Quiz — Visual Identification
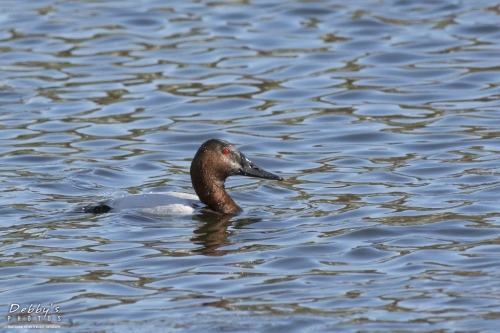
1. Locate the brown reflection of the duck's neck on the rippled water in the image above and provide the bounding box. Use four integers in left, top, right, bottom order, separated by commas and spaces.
191, 209, 260, 256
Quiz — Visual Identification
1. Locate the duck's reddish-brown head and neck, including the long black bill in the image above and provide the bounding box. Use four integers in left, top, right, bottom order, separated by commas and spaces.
190, 139, 283, 214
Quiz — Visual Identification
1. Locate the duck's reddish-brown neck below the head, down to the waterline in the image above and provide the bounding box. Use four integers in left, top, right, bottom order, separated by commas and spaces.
192, 177, 243, 214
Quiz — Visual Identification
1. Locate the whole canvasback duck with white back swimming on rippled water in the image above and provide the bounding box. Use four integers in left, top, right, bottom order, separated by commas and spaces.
82, 139, 283, 215
